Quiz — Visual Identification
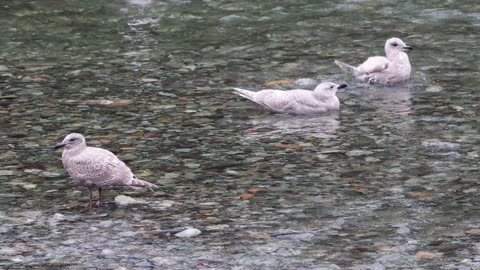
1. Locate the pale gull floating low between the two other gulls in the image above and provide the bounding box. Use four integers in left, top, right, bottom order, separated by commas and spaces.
233, 82, 347, 114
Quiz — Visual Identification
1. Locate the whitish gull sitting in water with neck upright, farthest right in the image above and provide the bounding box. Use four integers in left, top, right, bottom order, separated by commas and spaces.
335, 37, 412, 85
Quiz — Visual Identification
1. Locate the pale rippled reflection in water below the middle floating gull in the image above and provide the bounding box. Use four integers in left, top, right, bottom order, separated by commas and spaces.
242, 112, 340, 140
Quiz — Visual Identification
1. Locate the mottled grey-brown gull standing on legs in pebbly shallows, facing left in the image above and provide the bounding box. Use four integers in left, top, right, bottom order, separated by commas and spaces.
54, 133, 157, 209
